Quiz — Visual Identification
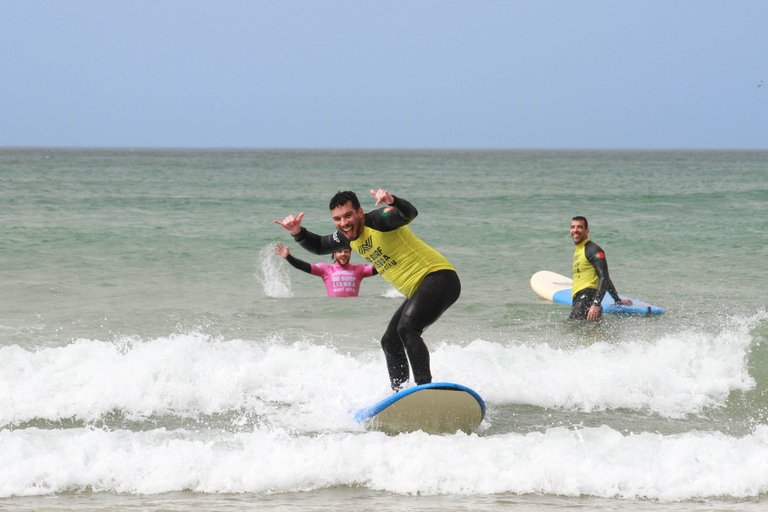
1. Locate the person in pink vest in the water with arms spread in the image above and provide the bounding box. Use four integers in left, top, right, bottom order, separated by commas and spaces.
275, 244, 378, 297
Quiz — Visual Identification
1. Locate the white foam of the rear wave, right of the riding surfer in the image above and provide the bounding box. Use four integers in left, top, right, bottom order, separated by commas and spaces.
433, 318, 755, 418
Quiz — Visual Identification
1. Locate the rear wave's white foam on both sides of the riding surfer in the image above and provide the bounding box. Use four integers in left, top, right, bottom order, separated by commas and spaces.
0, 314, 755, 431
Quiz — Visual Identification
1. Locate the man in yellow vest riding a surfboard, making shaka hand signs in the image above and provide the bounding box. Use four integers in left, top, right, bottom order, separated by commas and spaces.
275, 189, 461, 391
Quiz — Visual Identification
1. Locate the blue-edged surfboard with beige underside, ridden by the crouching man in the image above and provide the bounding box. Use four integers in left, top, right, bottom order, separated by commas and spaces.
355, 382, 485, 434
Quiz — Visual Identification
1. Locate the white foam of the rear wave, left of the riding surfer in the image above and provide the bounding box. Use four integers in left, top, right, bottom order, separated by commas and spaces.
0, 333, 386, 430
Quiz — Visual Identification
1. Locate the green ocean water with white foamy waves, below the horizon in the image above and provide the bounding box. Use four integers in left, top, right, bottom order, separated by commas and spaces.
0, 149, 768, 511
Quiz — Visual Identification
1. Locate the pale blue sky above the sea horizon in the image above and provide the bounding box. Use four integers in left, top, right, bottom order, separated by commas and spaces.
0, 0, 768, 149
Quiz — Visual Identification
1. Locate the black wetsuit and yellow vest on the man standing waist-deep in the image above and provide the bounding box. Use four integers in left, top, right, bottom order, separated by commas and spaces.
570, 239, 620, 320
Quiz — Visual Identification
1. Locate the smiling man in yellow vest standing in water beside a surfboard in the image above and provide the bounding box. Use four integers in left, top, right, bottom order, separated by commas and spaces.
570, 217, 632, 322
